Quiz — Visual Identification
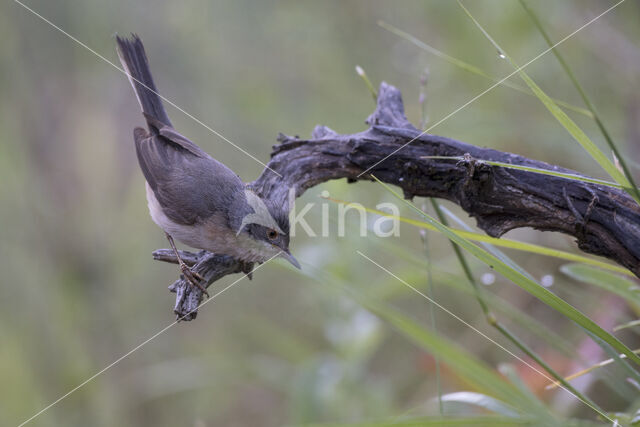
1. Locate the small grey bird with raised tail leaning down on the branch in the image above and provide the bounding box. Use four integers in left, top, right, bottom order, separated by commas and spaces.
116, 34, 300, 294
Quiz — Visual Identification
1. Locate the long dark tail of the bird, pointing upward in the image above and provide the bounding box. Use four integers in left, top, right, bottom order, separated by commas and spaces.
116, 34, 173, 130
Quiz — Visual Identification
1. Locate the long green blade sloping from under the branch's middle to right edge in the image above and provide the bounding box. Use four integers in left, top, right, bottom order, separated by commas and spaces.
372, 175, 640, 365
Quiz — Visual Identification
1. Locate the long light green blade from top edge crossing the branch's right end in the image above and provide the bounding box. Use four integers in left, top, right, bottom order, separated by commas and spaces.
458, 0, 640, 204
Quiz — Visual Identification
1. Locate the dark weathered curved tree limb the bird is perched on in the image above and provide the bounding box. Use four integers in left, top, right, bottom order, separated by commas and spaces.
154, 82, 640, 320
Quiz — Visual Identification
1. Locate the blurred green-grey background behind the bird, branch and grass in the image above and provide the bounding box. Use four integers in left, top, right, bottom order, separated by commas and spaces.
0, 0, 640, 427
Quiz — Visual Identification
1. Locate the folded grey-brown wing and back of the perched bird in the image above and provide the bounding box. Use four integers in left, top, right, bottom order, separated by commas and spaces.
134, 126, 244, 224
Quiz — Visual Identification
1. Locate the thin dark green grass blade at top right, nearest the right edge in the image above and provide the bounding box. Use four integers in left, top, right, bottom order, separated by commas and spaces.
520, 0, 640, 207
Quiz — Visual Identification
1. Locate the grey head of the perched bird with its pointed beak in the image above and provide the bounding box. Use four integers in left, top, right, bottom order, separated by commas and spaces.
231, 189, 300, 268
